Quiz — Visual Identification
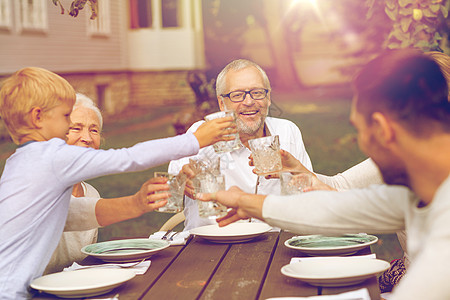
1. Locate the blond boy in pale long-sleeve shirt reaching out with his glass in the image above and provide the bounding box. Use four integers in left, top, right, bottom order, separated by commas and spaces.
0, 68, 235, 299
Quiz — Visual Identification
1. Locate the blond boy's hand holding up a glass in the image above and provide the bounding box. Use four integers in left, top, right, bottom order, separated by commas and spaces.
194, 117, 237, 148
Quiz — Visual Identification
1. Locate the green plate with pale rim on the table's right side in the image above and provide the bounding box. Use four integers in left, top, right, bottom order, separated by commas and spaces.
284, 233, 378, 255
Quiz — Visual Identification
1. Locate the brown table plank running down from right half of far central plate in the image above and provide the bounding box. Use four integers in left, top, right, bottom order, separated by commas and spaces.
200, 232, 278, 300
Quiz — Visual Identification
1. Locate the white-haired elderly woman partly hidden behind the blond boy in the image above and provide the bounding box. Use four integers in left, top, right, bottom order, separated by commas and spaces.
45, 94, 169, 274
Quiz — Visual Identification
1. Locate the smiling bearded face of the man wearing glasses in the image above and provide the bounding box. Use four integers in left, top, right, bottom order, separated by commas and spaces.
218, 66, 270, 138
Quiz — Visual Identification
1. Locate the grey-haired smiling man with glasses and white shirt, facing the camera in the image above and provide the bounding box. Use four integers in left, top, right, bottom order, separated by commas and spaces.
169, 59, 312, 230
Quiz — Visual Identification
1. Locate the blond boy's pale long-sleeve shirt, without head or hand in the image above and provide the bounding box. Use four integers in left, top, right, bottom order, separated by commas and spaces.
0, 134, 199, 299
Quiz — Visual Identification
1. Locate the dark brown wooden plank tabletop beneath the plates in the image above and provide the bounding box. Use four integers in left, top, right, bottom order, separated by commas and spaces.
33, 231, 380, 300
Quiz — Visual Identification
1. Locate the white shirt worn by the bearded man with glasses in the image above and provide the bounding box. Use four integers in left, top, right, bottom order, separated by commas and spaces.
169, 117, 312, 230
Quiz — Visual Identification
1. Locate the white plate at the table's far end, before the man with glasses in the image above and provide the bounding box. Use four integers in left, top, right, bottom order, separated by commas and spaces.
190, 223, 272, 243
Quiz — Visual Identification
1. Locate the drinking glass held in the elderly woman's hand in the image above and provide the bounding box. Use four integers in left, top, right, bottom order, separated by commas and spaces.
154, 172, 187, 213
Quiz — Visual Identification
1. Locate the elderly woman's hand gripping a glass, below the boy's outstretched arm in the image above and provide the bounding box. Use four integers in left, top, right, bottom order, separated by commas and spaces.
133, 177, 170, 213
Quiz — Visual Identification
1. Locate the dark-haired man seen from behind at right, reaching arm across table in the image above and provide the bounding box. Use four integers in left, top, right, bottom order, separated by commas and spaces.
198, 49, 450, 299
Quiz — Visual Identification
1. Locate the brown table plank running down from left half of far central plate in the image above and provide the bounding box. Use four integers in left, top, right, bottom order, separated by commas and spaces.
142, 237, 230, 300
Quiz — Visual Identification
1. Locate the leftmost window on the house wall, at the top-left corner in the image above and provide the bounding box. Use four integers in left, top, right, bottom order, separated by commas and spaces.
19, 0, 48, 30
